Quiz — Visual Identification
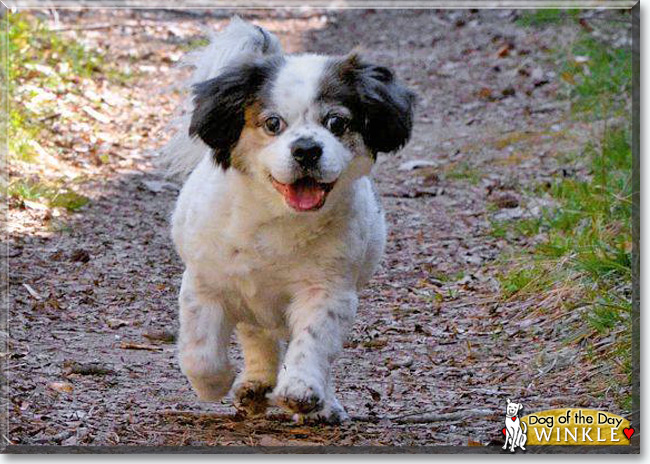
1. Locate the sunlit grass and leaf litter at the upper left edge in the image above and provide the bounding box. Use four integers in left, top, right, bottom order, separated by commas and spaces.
3, 12, 121, 211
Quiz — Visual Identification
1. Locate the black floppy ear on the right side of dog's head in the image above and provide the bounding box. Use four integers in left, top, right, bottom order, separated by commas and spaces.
347, 54, 415, 154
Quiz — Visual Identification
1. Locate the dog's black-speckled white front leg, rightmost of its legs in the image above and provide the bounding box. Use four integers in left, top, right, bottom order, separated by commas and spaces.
273, 289, 357, 422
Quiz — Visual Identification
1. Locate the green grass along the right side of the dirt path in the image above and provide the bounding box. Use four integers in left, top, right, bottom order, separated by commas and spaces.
491, 24, 632, 392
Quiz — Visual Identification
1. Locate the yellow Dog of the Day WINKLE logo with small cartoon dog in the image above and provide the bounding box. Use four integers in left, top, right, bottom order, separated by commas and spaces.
501, 399, 635, 453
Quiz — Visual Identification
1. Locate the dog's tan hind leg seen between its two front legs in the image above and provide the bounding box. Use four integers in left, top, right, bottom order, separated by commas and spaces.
234, 324, 280, 415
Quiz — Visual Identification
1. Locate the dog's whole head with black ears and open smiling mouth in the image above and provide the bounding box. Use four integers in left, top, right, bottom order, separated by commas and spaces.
190, 54, 414, 212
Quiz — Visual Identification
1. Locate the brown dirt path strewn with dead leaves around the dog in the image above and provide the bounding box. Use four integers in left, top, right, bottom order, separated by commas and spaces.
8, 10, 615, 446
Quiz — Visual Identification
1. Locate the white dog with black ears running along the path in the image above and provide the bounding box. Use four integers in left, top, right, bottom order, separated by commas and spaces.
165, 18, 414, 421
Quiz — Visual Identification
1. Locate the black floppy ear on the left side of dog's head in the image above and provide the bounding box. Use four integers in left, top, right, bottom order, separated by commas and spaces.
189, 56, 284, 169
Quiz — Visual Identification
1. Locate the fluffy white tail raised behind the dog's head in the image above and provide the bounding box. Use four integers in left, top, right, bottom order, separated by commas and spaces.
160, 16, 282, 178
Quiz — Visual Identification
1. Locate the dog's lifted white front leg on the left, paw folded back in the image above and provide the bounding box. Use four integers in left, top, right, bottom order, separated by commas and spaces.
178, 271, 234, 401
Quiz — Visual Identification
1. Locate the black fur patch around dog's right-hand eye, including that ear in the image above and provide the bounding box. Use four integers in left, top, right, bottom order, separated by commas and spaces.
319, 54, 415, 156
